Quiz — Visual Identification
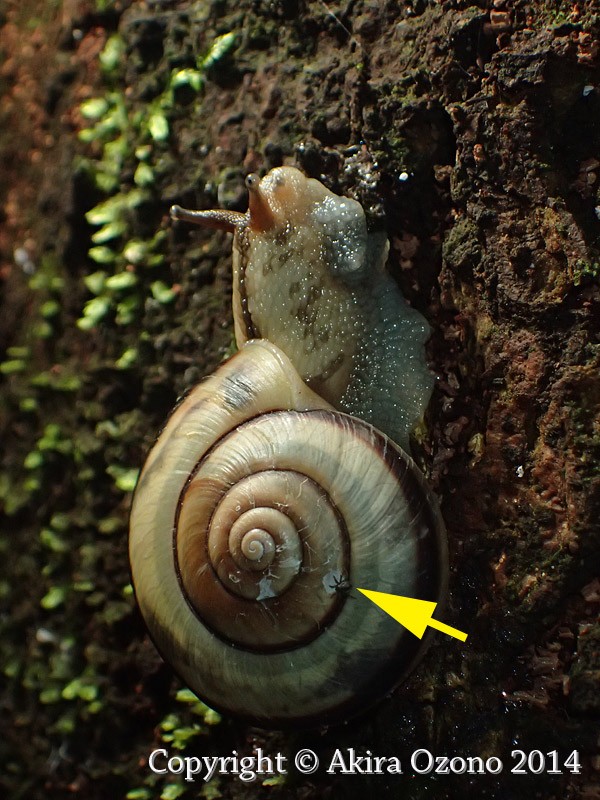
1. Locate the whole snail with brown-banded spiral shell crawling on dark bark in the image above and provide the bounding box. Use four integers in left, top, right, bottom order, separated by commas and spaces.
130, 167, 447, 728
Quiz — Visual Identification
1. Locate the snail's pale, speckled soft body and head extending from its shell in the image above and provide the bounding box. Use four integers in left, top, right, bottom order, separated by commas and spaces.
171, 167, 433, 449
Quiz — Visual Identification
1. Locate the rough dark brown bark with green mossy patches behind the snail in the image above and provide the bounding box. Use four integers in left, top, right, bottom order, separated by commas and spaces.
0, 0, 600, 800
